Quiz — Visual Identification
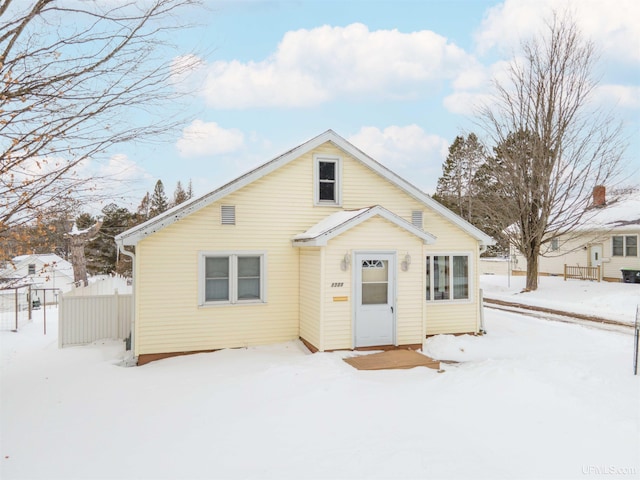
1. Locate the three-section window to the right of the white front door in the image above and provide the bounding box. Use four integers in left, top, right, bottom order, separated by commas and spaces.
426, 254, 471, 300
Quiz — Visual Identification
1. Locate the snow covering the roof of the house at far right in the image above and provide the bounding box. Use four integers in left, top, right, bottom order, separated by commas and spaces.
578, 190, 640, 231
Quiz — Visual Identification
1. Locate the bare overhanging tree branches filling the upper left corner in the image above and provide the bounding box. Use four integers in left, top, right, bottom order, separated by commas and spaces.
0, 0, 199, 235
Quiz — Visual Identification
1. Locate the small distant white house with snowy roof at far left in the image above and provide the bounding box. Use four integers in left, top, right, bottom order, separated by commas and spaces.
0, 253, 73, 292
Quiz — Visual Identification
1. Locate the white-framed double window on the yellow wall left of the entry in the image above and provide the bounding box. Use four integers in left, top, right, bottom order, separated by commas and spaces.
200, 252, 265, 305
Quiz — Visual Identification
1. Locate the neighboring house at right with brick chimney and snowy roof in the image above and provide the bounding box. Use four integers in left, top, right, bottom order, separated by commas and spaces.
515, 186, 640, 282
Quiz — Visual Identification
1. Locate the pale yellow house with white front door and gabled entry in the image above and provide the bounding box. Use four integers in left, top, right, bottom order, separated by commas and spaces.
116, 130, 493, 364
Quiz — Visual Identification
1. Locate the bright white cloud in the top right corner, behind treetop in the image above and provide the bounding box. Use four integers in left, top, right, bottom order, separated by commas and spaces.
476, 0, 640, 62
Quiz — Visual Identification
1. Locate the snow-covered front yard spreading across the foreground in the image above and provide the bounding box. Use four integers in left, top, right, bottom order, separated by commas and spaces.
0, 286, 640, 479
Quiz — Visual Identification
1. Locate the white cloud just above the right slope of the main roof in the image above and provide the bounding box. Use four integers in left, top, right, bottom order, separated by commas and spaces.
348, 125, 449, 192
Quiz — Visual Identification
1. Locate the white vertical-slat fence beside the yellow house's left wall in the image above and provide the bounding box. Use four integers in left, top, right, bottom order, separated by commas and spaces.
58, 292, 133, 348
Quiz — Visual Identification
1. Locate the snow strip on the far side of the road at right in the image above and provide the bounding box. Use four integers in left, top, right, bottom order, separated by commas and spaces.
480, 275, 640, 324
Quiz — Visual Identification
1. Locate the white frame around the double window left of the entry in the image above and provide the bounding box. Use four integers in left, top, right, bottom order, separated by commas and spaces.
198, 250, 267, 307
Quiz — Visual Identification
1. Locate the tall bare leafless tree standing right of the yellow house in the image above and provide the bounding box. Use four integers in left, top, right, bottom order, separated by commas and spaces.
479, 13, 625, 290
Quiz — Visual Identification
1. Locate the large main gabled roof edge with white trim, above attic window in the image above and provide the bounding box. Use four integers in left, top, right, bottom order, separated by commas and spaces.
115, 130, 495, 245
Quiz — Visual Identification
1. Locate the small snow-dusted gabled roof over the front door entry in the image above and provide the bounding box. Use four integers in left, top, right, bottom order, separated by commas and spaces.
293, 205, 436, 247
